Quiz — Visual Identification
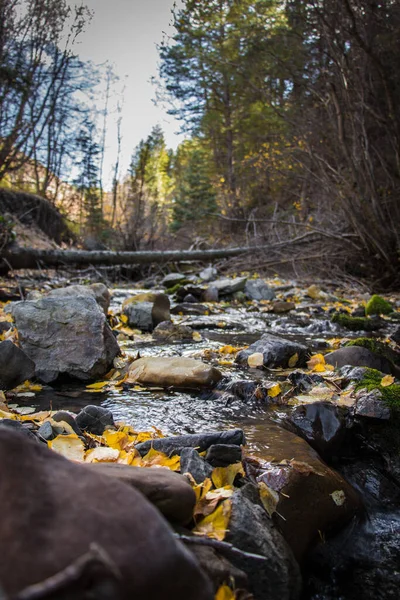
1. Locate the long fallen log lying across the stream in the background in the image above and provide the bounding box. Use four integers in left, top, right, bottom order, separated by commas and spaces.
0, 246, 264, 269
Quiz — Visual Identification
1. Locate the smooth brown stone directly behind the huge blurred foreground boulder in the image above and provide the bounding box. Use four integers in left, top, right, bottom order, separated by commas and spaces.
84, 462, 196, 525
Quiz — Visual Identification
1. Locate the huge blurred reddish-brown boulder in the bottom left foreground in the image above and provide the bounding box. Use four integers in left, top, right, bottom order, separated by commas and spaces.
0, 428, 213, 600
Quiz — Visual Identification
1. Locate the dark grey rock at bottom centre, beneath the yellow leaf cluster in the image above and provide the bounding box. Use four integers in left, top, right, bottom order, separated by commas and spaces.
225, 485, 301, 600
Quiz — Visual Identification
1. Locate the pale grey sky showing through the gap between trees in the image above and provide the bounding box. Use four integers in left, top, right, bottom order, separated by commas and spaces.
69, 0, 183, 188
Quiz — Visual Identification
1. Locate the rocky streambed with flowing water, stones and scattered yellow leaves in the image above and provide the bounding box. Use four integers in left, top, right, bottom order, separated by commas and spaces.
0, 270, 400, 600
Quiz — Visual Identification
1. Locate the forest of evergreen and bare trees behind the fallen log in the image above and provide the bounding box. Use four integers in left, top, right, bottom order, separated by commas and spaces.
0, 0, 400, 286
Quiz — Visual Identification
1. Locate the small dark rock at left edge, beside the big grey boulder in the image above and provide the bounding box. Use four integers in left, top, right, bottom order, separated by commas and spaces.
0, 340, 35, 390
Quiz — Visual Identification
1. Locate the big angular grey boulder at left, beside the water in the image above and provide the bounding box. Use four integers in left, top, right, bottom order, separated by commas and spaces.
11, 296, 120, 383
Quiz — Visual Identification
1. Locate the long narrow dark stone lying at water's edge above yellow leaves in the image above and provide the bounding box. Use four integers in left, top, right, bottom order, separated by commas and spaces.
135, 429, 246, 456
